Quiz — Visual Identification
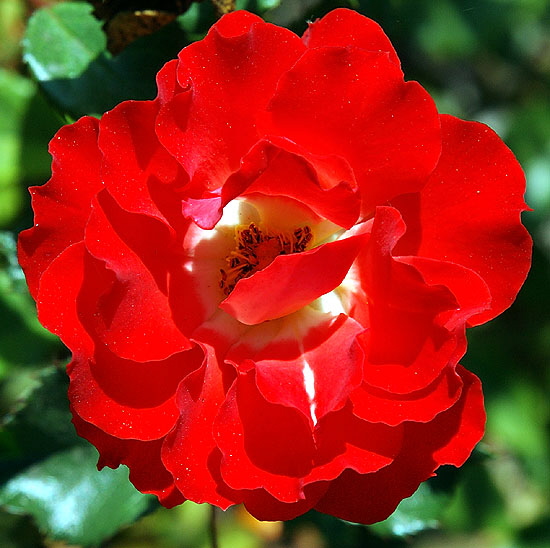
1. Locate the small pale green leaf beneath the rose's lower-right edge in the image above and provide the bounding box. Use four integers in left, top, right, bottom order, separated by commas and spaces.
369, 482, 450, 537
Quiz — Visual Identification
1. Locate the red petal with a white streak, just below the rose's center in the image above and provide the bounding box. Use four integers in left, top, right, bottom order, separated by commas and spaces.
239, 311, 364, 426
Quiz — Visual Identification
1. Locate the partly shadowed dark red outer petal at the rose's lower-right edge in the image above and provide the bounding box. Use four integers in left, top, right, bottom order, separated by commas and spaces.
315, 368, 485, 523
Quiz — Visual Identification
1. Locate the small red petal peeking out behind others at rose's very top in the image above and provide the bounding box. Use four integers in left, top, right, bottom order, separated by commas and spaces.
302, 8, 400, 66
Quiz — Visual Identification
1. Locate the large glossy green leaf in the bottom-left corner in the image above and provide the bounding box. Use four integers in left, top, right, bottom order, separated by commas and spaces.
0, 446, 152, 546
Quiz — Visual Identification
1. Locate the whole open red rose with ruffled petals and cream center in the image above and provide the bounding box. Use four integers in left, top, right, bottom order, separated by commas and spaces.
19, 10, 531, 523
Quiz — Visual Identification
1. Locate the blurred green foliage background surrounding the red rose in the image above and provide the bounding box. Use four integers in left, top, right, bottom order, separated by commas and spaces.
0, 0, 550, 548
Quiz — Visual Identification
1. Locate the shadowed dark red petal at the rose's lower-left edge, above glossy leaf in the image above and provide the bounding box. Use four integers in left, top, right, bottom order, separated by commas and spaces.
73, 415, 185, 508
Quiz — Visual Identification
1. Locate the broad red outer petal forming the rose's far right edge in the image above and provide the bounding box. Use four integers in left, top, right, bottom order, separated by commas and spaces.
394, 116, 532, 325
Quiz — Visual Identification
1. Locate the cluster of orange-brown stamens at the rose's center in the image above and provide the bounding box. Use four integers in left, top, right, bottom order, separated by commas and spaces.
220, 223, 313, 296
